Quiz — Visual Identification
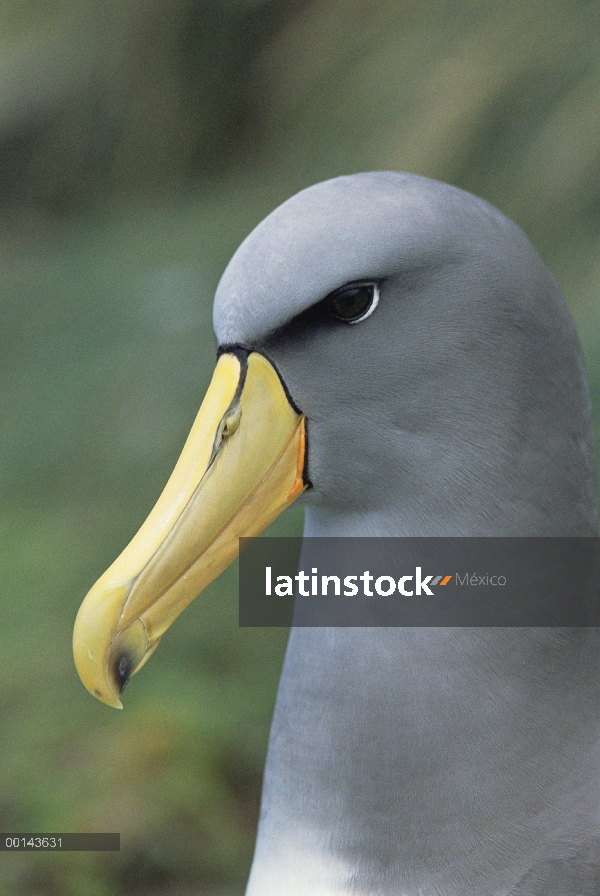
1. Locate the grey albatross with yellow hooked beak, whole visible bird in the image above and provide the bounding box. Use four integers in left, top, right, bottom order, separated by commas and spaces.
74, 172, 600, 896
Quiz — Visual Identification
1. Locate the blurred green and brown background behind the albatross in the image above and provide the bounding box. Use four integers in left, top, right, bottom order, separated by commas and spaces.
0, 0, 600, 896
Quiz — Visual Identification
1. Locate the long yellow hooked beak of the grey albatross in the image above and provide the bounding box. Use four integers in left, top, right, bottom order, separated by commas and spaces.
73, 351, 307, 709
